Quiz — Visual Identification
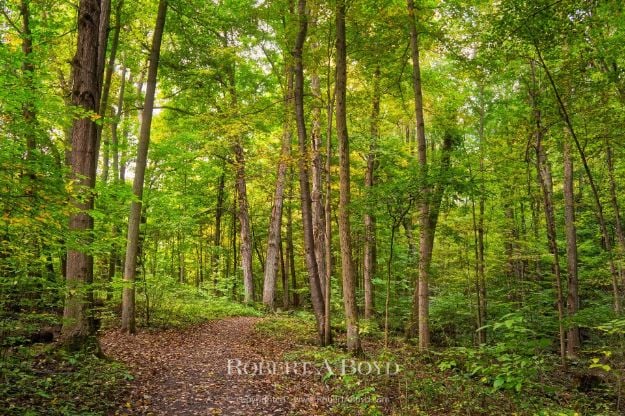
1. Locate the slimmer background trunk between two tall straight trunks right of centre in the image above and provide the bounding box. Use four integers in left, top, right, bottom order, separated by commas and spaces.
363, 66, 380, 319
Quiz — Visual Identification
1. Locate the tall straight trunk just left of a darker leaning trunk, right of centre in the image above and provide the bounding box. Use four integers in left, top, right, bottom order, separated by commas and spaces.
408, 0, 434, 351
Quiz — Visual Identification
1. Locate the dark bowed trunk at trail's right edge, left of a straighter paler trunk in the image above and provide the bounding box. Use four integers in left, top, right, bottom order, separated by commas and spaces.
293, 0, 325, 344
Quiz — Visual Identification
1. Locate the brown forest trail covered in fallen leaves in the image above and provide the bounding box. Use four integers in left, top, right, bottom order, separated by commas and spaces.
101, 317, 327, 416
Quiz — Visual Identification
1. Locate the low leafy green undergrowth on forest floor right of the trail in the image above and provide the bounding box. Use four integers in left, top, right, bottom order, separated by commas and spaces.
257, 313, 618, 416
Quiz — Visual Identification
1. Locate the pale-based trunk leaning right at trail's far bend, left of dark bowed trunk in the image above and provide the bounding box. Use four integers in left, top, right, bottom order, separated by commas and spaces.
263, 65, 293, 310
